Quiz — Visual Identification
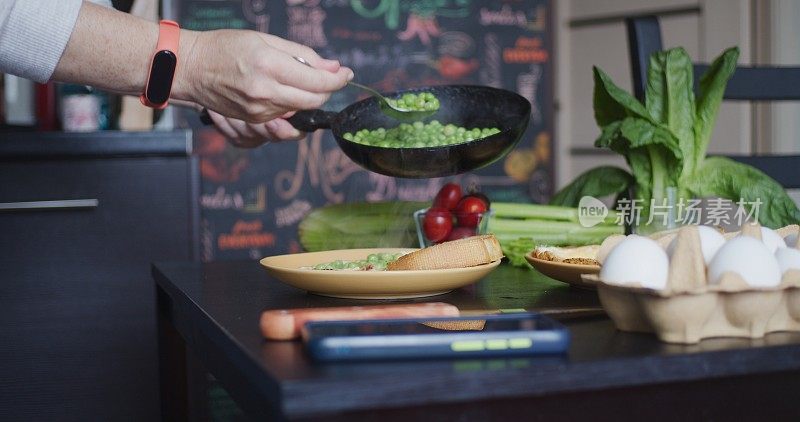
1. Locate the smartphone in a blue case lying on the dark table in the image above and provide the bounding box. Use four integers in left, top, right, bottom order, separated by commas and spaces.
303, 312, 570, 361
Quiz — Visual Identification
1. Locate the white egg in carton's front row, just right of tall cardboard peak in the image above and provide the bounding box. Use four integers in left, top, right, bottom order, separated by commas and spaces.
708, 236, 781, 287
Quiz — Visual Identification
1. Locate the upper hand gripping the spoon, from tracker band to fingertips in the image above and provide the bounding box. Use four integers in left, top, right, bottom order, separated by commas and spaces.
173, 30, 353, 123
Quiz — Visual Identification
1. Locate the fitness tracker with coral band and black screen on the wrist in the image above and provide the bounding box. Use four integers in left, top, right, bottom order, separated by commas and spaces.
139, 20, 181, 109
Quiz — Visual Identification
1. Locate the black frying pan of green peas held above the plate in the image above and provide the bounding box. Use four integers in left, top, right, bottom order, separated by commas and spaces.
200, 85, 531, 178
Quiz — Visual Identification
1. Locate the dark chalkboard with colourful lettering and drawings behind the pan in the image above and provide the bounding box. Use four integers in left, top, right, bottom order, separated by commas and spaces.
173, 0, 553, 260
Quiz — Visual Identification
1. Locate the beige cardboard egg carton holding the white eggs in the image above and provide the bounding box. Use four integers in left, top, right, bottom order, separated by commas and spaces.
583, 226, 800, 344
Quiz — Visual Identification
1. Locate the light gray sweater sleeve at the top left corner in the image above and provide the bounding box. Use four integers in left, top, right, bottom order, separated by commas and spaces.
0, 0, 81, 82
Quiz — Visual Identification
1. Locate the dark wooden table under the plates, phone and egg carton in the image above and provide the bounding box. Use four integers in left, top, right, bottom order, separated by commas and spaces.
153, 262, 800, 421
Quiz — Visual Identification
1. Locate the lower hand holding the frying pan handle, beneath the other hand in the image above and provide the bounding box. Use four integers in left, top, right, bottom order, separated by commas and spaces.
208, 110, 303, 148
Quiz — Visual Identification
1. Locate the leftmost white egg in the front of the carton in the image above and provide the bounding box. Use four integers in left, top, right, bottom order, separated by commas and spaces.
600, 235, 669, 289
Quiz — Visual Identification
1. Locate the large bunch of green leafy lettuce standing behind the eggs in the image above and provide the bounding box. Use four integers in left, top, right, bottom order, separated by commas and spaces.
551, 47, 800, 228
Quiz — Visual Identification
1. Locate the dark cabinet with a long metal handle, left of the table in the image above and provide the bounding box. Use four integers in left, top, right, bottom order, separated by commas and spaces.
0, 132, 199, 421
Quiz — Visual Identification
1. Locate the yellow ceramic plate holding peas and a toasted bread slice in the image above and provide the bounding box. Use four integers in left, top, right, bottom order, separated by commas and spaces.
261, 248, 500, 299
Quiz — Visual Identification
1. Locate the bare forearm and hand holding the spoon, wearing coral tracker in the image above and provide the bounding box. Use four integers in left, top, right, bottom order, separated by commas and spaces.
4, 0, 352, 145
